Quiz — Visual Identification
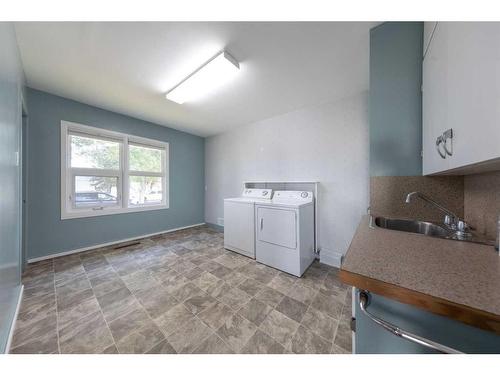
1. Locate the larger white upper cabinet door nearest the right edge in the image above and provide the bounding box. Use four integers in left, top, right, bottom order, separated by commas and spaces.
443, 22, 500, 169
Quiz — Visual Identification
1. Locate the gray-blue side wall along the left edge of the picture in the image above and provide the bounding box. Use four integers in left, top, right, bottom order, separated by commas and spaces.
0, 22, 24, 353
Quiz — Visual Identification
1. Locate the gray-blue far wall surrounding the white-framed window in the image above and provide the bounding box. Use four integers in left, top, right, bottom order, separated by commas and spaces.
27, 89, 205, 259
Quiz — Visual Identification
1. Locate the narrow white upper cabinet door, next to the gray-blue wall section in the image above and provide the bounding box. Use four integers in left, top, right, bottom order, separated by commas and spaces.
422, 23, 449, 175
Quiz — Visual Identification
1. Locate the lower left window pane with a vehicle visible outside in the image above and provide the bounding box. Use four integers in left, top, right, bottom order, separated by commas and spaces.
74, 176, 118, 208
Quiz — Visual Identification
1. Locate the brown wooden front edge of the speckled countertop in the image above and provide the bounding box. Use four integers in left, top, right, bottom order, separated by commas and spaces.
339, 269, 500, 334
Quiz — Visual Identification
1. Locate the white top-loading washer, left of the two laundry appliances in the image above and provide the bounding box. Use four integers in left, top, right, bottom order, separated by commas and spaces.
224, 188, 273, 259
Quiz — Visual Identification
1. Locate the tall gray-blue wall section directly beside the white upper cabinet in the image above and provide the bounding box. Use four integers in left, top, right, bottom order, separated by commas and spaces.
370, 22, 423, 176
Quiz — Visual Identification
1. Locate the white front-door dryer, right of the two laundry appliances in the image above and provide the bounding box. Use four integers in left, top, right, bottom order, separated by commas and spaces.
255, 191, 315, 277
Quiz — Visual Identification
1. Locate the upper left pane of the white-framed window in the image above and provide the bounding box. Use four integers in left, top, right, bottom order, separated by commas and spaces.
70, 135, 120, 169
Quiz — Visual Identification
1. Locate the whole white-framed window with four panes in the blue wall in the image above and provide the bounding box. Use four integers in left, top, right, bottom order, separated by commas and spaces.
61, 121, 168, 219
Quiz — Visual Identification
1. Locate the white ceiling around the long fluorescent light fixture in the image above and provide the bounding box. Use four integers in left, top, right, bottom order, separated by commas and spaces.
16, 22, 375, 136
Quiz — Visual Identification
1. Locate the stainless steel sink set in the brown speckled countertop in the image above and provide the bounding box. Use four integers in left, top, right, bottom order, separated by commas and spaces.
370, 216, 494, 245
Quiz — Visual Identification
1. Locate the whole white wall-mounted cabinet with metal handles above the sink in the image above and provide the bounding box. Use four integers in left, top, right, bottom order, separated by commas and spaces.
422, 22, 500, 175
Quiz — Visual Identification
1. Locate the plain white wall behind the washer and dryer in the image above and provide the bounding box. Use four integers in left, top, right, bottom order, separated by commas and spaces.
205, 92, 369, 264
